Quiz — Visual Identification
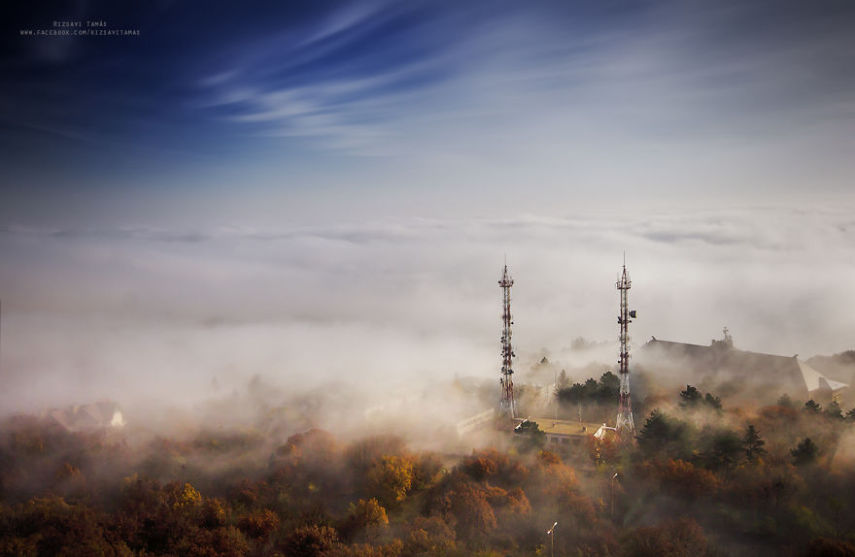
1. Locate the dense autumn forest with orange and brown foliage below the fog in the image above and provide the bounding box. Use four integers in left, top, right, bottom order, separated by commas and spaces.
0, 382, 855, 557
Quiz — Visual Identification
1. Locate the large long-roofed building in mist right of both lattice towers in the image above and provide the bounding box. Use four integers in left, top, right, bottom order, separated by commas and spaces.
637, 328, 849, 402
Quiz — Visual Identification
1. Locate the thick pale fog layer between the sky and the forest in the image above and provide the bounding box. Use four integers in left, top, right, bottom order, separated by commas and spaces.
0, 202, 855, 412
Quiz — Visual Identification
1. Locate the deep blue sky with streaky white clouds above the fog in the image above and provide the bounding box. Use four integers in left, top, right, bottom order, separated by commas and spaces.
0, 0, 855, 222
